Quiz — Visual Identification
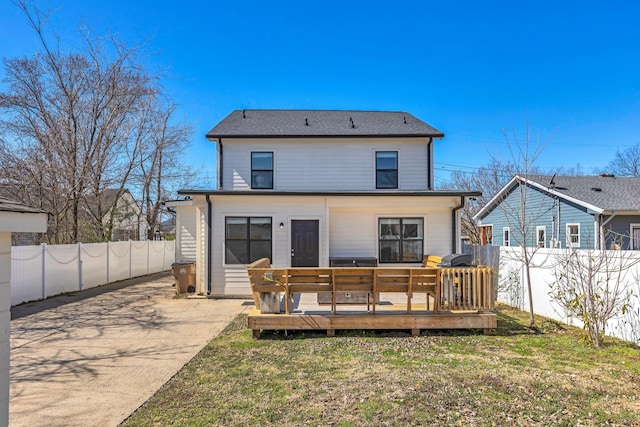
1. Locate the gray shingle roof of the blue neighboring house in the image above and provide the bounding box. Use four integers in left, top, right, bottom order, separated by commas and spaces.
527, 175, 640, 211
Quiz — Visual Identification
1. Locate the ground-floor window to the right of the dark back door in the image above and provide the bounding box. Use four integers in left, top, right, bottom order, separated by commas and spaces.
378, 218, 424, 263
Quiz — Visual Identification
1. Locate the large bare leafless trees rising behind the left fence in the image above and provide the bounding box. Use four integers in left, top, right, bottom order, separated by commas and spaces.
0, 0, 188, 243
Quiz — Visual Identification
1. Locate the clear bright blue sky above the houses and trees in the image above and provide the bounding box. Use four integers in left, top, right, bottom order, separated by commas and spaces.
0, 0, 640, 188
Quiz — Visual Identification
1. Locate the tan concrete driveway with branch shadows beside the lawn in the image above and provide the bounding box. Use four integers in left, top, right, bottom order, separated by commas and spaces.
9, 273, 253, 427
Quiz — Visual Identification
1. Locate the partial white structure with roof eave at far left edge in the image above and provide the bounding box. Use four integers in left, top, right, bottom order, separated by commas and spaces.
0, 197, 47, 426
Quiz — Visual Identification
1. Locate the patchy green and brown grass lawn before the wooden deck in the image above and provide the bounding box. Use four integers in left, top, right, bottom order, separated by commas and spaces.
124, 306, 640, 426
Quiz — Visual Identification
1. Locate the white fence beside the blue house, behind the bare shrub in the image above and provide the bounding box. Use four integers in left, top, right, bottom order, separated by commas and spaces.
498, 247, 640, 344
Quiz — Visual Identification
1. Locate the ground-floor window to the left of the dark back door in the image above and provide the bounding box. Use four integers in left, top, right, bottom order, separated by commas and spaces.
225, 216, 271, 264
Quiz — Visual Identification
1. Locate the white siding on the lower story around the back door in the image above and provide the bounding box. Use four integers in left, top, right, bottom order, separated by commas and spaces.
196, 195, 459, 295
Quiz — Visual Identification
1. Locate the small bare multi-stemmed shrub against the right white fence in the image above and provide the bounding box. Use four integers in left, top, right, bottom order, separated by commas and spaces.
550, 242, 639, 347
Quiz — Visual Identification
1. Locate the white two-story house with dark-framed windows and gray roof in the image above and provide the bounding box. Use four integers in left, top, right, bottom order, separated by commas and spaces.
169, 110, 480, 295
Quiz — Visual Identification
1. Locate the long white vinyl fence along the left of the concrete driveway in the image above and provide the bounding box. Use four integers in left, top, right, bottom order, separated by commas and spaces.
11, 240, 175, 306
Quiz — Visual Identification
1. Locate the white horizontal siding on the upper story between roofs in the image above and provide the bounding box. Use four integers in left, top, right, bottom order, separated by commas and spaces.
223, 138, 429, 191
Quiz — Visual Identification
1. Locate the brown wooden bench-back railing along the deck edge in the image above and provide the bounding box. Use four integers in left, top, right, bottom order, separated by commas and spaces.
247, 258, 495, 314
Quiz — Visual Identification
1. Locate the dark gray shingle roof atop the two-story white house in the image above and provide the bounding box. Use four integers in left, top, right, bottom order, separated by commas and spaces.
207, 110, 444, 139
